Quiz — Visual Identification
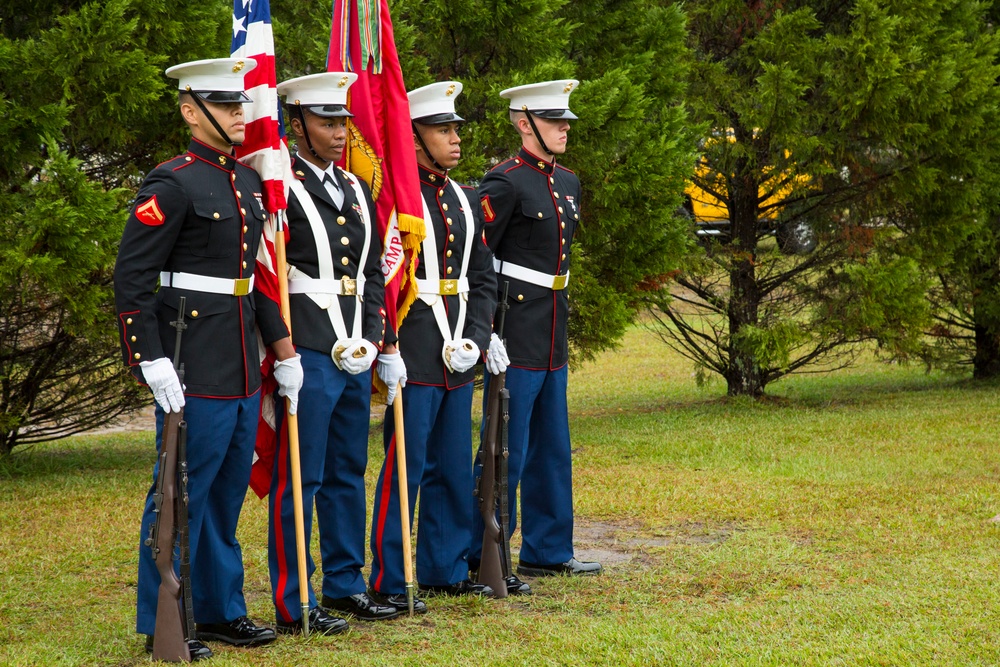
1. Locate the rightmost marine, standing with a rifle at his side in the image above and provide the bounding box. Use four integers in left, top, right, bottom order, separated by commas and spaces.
471, 80, 601, 576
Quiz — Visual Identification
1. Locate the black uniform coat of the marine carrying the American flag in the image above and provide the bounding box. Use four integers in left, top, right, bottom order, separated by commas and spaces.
285, 155, 395, 354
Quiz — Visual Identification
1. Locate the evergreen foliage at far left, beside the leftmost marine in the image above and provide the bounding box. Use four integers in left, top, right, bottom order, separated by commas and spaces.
0, 0, 229, 456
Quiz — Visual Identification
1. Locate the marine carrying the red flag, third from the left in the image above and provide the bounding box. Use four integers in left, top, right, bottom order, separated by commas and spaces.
369, 81, 502, 609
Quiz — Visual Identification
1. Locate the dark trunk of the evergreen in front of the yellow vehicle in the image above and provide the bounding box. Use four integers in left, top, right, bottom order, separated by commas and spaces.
726, 157, 764, 396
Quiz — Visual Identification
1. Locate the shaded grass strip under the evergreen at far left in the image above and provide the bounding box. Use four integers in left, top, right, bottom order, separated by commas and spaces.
0, 433, 155, 481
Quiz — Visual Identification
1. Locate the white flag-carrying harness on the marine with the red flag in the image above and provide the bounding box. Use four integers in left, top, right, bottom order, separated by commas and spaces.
417, 179, 476, 341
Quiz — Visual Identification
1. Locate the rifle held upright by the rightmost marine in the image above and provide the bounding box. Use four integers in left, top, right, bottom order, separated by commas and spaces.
476, 281, 512, 598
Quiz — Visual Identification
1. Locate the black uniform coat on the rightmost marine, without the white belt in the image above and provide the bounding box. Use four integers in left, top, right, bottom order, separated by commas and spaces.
479, 148, 580, 370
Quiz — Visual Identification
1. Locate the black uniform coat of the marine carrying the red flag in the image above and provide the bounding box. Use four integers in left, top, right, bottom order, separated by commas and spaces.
399, 167, 497, 389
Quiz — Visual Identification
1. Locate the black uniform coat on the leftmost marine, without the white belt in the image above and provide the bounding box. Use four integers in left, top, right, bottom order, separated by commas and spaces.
114, 139, 288, 398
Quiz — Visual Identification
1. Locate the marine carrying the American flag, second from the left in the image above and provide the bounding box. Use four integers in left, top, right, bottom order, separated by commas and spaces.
268, 72, 398, 634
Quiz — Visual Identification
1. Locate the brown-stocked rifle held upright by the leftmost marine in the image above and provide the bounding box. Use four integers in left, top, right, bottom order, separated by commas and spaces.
145, 296, 194, 662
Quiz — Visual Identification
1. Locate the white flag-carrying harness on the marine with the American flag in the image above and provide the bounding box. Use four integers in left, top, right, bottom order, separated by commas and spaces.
288, 172, 372, 340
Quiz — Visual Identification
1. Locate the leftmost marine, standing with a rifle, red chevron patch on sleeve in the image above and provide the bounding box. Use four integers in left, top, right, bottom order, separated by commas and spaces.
114, 58, 301, 659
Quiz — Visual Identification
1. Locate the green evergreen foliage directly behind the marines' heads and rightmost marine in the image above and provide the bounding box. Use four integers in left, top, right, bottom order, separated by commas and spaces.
272, 0, 694, 359
